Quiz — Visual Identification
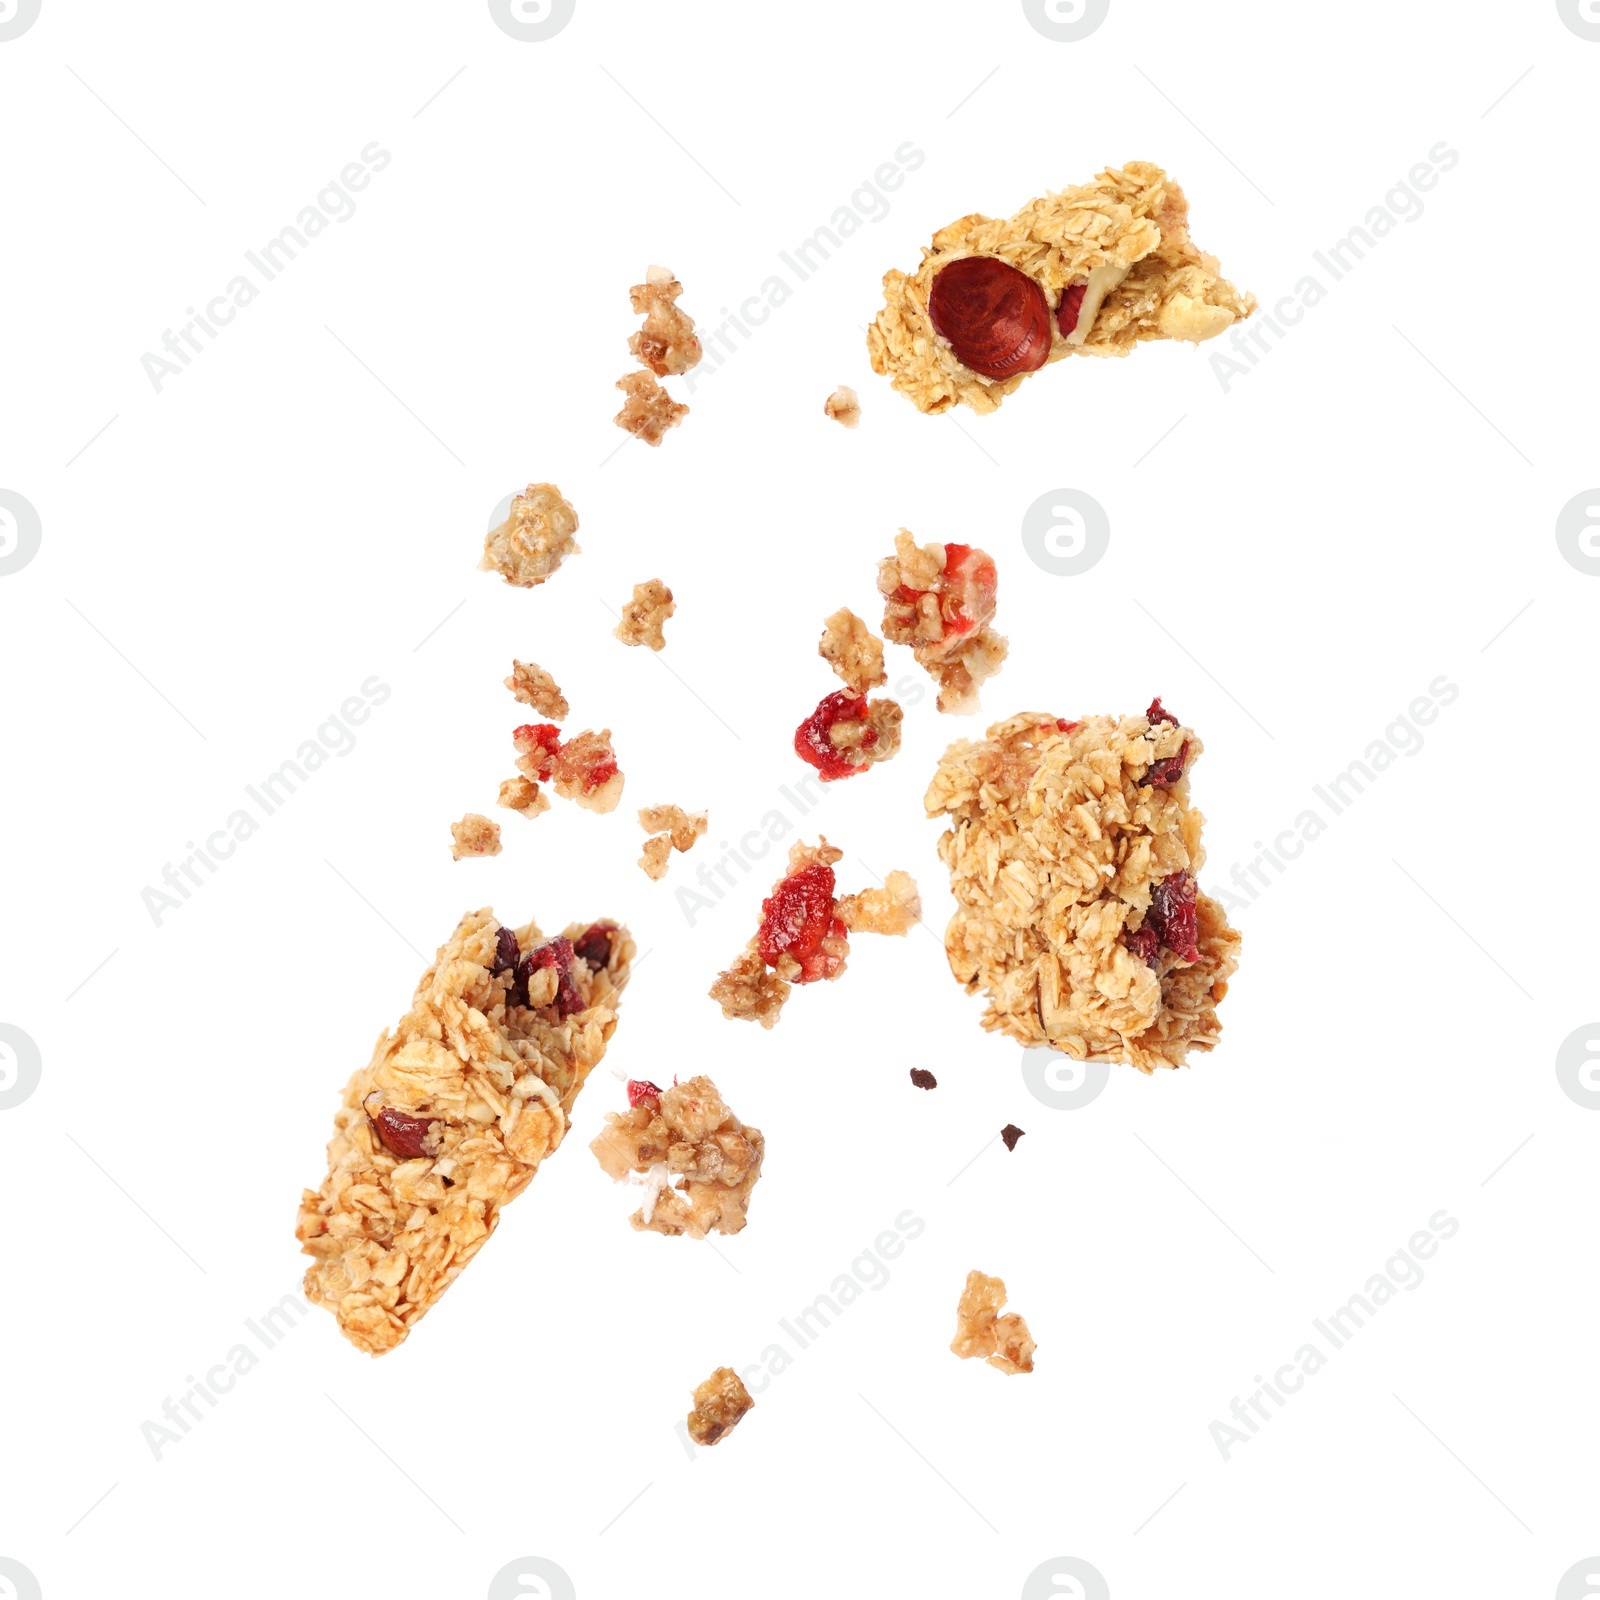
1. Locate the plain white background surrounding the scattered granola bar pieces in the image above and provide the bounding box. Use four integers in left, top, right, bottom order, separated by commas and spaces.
0, 0, 1600, 1600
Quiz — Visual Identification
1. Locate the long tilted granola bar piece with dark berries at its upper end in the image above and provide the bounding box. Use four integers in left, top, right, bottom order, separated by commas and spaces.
294, 909, 635, 1355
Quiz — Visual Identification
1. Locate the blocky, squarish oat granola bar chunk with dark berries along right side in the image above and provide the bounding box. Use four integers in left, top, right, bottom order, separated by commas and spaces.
925, 702, 1240, 1072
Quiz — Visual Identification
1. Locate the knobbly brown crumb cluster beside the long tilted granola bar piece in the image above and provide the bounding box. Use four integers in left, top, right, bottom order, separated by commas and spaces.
589, 1077, 766, 1238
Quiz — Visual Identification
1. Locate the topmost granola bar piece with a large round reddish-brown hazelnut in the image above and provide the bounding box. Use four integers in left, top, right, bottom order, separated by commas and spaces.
867, 162, 1256, 413
